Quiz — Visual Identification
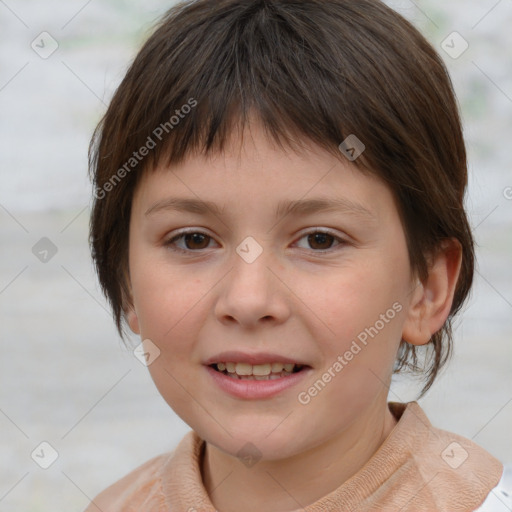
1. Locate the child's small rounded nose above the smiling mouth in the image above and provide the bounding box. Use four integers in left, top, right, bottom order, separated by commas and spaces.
214, 247, 290, 329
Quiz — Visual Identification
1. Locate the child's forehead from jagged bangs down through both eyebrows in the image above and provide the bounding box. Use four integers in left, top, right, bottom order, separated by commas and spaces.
135, 123, 394, 226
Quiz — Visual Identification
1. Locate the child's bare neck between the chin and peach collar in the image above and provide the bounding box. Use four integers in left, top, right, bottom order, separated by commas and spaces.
202, 401, 396, 512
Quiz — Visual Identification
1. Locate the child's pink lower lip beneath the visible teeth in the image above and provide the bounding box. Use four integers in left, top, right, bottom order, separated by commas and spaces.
206, 366, 311, 400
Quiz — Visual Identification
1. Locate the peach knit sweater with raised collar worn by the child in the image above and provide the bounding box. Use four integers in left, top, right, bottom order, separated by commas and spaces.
85, 402, 503, 512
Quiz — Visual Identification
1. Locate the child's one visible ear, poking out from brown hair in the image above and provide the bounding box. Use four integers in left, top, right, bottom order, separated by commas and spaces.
402, 239, 462, 345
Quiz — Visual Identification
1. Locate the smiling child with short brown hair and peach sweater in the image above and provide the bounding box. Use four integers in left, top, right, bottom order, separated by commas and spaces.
87, 0, 506, 512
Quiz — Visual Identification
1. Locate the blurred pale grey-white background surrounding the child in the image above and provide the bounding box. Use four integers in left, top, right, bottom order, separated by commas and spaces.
0, 0, 512, 512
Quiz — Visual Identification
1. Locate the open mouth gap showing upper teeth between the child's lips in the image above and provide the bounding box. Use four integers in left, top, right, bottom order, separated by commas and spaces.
209, 361, 309, 381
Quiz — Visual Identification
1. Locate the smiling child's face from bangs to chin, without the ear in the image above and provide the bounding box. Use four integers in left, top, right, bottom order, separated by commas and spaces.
128, 125, 412, 460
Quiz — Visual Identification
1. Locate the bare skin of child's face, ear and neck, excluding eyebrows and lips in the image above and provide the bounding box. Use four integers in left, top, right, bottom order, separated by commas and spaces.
127, 123, 460, 512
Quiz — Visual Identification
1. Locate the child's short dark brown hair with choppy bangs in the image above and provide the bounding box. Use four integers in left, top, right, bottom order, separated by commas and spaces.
89, 0, 474, 394
